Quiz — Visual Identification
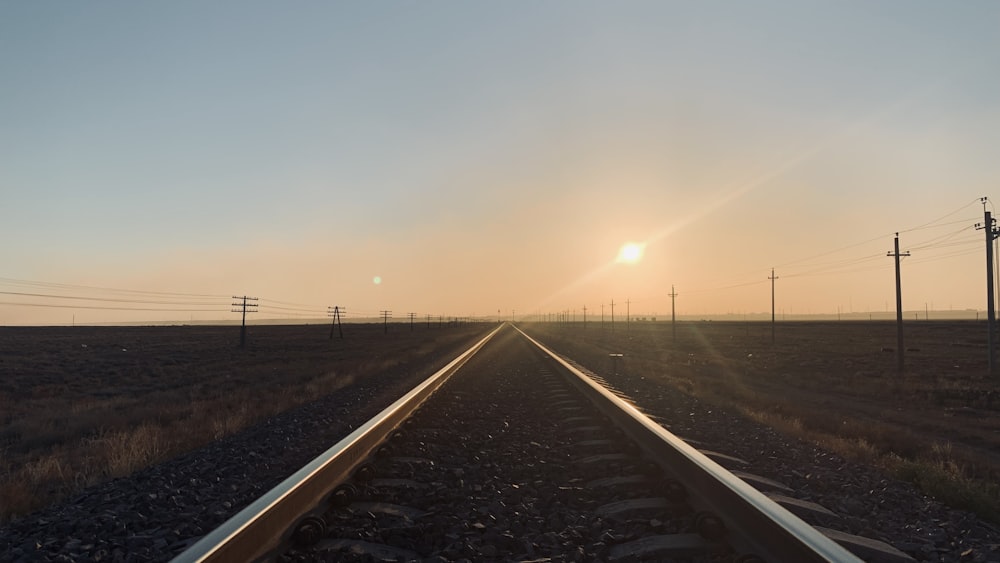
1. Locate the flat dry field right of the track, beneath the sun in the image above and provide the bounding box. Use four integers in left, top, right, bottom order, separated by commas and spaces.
523, 321, 1000, 521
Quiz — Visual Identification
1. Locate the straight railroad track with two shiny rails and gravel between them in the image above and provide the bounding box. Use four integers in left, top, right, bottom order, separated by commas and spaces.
175, 325, 909, 563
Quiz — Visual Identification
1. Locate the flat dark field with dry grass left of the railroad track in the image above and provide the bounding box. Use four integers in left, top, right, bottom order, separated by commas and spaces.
0, 324, 491, 521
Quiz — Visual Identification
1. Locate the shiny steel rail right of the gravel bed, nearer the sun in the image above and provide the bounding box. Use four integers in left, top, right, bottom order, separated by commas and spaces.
514, 326, 861, 563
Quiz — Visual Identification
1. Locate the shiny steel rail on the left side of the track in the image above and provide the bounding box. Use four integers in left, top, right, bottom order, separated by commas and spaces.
173, 325, 505, 563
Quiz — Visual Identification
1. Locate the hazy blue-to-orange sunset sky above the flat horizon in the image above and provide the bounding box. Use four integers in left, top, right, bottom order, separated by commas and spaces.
0, 0, 1000, 325
